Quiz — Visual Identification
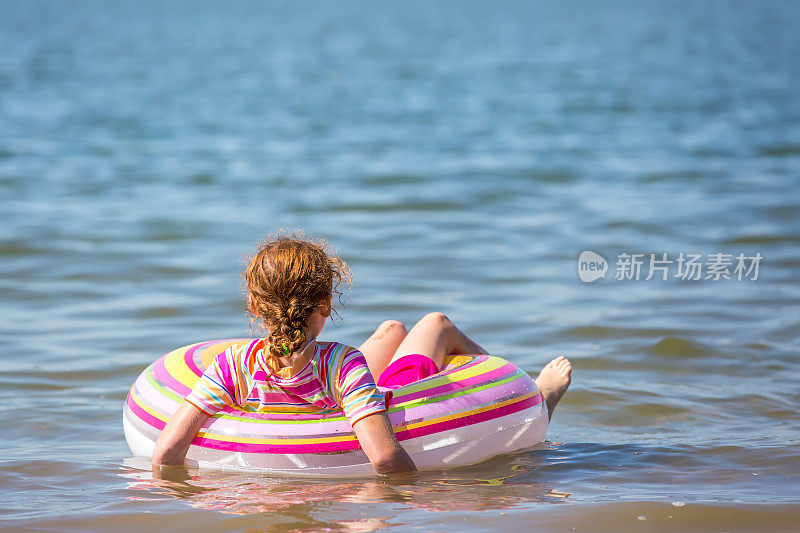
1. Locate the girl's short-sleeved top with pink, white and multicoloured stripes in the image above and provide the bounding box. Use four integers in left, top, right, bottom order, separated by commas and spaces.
186, 339, 391, 425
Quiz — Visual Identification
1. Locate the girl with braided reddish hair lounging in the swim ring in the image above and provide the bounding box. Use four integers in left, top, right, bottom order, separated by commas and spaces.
152, 236, 572, 474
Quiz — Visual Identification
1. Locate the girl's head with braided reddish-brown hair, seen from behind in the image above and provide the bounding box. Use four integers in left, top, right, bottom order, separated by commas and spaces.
244, 235, 350, 357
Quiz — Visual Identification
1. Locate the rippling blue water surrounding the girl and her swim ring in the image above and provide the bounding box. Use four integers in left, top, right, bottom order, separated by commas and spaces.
0, 1, 800, 531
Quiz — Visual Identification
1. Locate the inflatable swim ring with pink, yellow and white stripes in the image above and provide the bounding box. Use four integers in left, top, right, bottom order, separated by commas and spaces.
122, 339, 548, 476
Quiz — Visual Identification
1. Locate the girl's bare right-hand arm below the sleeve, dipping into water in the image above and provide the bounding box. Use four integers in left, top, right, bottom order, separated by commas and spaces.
353, 411, 417, 475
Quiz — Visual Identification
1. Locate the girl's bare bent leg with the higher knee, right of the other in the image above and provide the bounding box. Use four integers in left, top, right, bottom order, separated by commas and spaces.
384, 313, 488, 369
